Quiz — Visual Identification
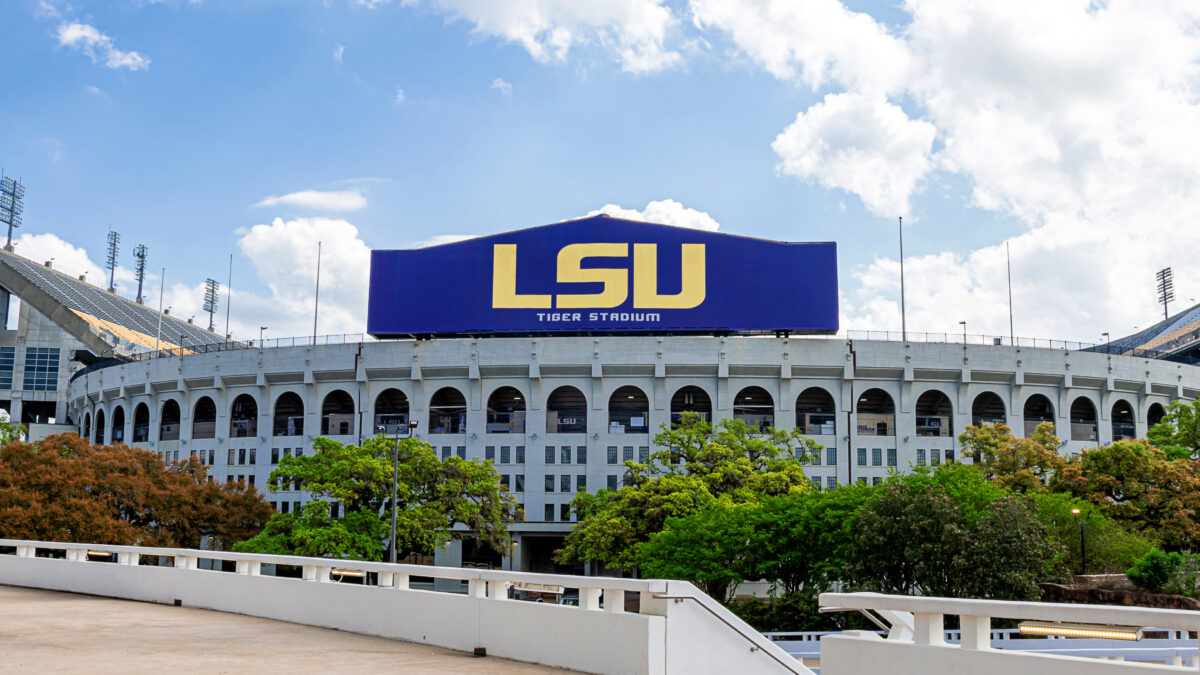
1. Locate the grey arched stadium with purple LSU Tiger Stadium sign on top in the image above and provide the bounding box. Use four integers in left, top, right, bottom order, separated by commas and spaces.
0, 216, 1185, 571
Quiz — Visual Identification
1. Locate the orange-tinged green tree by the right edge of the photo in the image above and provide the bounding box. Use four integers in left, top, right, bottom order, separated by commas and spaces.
1050, 441, 1200, 550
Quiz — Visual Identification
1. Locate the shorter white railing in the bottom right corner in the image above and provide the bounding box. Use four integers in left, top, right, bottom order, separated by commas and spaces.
820, 593, 1200, 675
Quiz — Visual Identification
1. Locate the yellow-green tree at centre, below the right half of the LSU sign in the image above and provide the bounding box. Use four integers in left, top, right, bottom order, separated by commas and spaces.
557, 413, 817, 569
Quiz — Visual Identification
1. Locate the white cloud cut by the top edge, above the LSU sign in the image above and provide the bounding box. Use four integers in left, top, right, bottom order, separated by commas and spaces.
403, 0, 683, 73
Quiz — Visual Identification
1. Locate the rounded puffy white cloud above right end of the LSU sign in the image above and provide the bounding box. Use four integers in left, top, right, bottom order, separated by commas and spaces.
770, 94, 937, 216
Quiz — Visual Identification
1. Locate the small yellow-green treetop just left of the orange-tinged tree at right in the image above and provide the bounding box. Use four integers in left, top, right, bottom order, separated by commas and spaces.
959, 422, 1063, 492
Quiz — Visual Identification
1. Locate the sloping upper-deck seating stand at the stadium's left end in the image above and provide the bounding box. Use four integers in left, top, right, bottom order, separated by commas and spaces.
0, 249, 221, 360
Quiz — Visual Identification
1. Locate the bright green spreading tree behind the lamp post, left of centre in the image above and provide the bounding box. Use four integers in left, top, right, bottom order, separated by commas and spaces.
235, 436, 517, 560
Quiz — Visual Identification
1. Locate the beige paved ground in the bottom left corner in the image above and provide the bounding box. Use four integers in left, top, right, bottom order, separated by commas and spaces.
0, 586, 576, 675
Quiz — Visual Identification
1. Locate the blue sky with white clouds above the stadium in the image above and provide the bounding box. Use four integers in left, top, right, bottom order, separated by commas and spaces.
0, 0, 1200, 342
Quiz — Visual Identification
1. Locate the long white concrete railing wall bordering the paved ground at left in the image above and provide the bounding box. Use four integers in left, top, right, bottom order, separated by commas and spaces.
0, 539, 811, 675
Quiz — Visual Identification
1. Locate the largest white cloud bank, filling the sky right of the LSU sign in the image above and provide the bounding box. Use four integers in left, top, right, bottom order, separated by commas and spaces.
690, 0, 1200, 340
